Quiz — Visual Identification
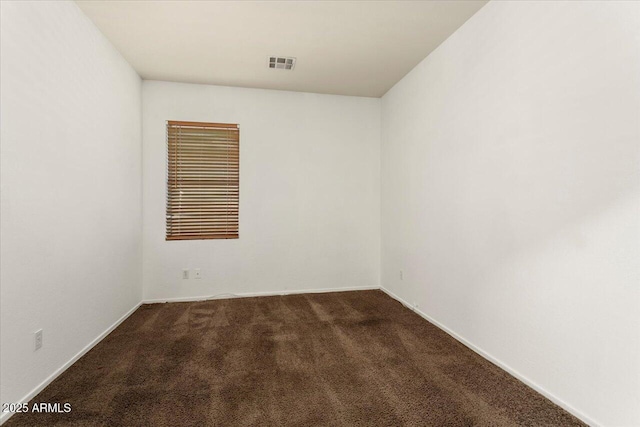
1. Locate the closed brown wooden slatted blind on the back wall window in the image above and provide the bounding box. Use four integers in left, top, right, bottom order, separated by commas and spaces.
166, 121, 240, 240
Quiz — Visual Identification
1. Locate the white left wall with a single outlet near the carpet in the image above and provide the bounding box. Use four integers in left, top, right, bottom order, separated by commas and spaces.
0, 1, 142, 416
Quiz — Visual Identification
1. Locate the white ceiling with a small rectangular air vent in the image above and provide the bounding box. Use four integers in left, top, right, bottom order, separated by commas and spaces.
77, 1, 486, 97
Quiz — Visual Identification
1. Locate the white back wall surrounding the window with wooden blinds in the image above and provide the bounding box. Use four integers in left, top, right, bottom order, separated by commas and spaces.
142, 81, 380, 299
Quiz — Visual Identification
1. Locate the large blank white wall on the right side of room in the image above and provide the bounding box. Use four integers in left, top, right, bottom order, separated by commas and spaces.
382, 2, 640, 426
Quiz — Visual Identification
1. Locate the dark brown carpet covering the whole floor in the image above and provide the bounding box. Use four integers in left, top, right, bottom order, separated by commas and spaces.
6, 291, 583, 427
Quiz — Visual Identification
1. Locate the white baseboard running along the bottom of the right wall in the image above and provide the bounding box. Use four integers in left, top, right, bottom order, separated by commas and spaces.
380, 287, 600, 427
